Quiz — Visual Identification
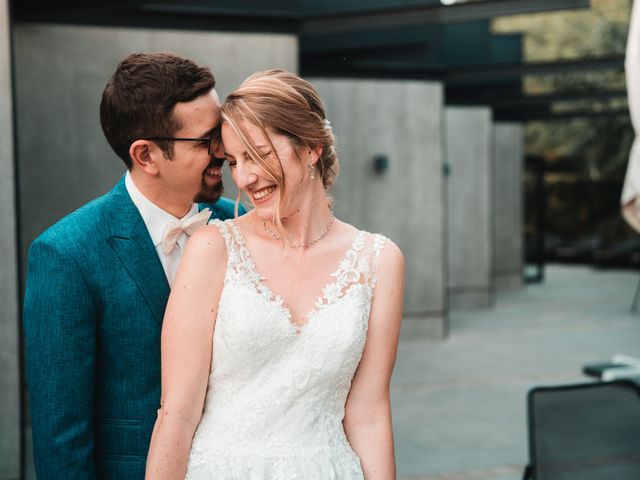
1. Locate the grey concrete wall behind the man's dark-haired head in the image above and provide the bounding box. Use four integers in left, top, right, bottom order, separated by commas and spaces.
15, 24, 298, 258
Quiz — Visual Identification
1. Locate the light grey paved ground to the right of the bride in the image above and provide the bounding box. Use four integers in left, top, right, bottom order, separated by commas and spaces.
392, 266, 640, 480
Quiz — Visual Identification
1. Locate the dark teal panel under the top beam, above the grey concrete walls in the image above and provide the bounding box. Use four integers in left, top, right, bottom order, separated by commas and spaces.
300, 20, 522, 85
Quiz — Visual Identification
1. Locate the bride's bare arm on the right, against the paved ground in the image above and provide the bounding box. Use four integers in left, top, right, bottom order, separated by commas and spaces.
343, 242, 404, 480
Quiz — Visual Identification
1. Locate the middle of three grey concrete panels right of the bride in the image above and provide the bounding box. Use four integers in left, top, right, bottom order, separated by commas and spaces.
445, 107, 494, 309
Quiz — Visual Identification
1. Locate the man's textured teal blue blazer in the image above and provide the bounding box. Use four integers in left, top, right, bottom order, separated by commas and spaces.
23, 178, 244, 480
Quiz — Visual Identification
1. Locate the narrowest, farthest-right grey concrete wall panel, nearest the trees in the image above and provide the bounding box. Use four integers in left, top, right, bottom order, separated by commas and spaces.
493, 123, 524, 290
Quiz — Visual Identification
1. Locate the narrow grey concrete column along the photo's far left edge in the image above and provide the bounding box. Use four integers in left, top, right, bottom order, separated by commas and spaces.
0, 0, 20, 479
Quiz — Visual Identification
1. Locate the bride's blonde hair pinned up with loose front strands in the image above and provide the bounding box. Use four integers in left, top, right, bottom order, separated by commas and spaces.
222, 70, 340, 232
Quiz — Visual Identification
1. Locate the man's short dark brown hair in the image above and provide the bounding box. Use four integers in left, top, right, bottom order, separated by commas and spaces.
100, 53, 216, 169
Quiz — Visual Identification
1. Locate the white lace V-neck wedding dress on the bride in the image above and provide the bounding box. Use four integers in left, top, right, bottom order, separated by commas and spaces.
186, 220, 386, 480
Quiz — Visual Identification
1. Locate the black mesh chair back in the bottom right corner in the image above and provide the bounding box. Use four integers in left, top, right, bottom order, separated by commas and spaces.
523, 380, 640, 480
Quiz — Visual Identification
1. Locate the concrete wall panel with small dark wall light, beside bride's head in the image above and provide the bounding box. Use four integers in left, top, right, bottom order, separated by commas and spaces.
313, 80, 446, 338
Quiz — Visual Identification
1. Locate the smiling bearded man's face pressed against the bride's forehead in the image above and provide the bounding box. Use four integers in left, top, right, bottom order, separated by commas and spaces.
160, 90, 224, 203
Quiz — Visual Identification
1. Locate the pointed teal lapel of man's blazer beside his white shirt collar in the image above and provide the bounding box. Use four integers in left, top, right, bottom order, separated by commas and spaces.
103, 178, 170, 322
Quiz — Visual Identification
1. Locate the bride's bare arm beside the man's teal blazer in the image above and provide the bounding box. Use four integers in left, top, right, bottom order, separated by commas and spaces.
146, 226, 226, 480
